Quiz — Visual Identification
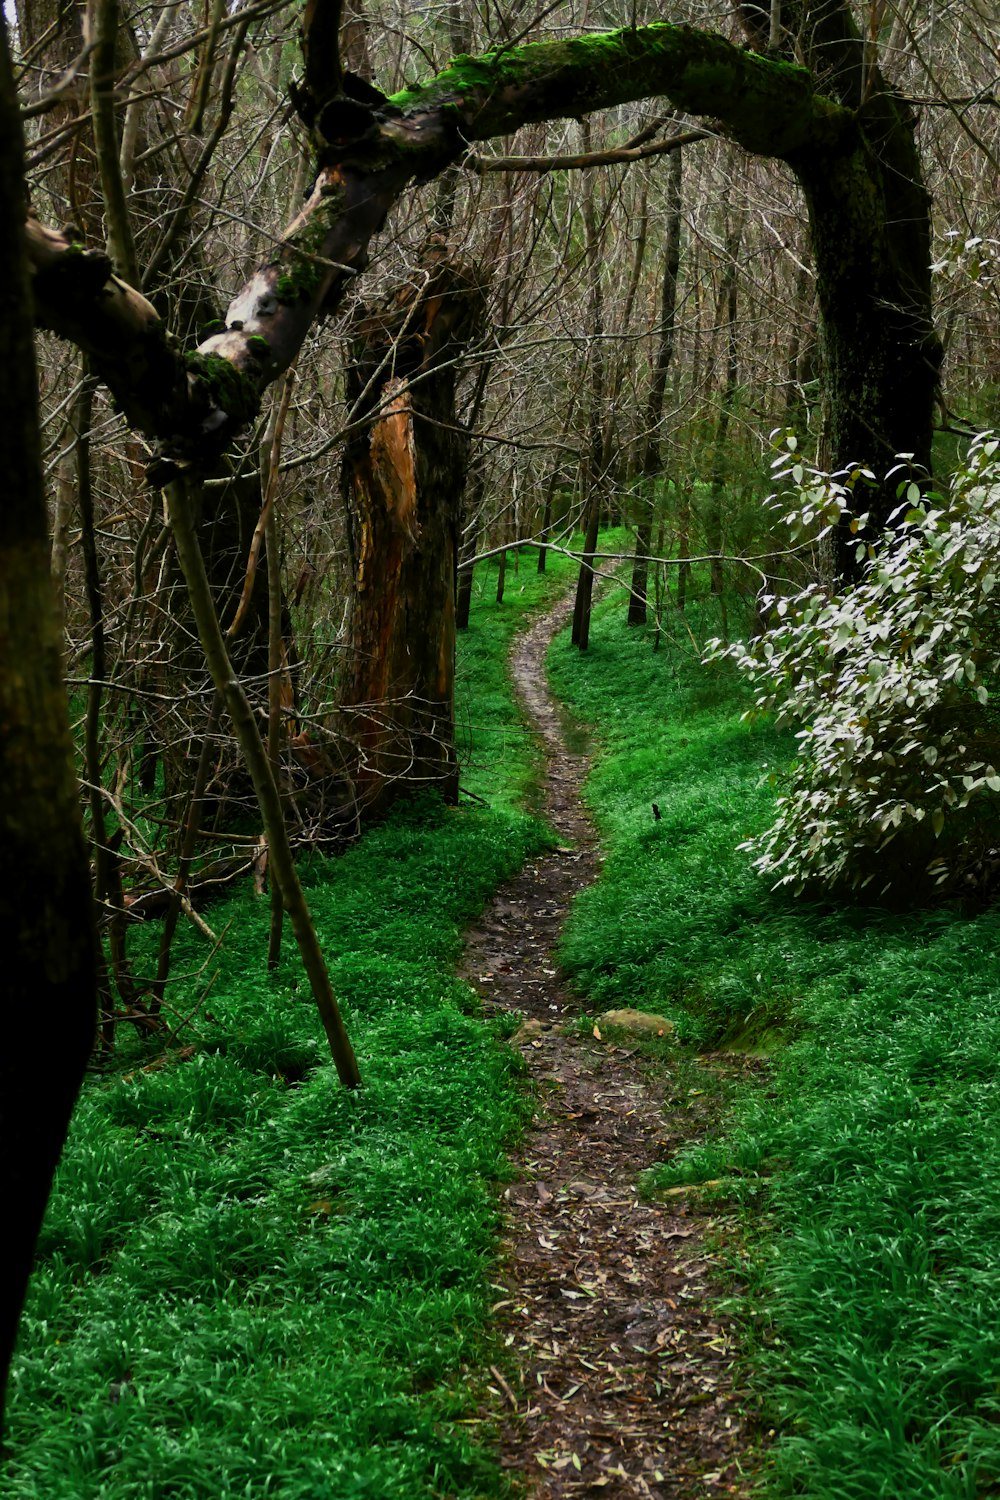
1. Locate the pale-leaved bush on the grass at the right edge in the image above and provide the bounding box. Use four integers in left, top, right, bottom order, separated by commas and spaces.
708, 435, 1000, 894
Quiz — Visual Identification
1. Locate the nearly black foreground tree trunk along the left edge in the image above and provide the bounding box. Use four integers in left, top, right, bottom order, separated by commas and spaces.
0, 23, 96, 1422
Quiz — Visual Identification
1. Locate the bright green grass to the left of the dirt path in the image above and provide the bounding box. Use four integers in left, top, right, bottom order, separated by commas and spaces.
0, 555, 569, 1500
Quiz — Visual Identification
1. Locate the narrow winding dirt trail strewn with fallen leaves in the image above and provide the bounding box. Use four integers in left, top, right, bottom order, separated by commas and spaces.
465, 602, 750, 1500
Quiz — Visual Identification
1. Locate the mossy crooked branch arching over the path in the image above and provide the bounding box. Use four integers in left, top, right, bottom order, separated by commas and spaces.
28, 17, 855, 471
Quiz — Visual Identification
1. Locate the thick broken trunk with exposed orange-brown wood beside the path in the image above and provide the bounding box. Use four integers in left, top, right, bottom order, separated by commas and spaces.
340, 260, 483, 816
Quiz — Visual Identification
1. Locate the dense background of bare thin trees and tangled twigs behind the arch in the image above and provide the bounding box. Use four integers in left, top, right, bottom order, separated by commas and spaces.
15, 0, 999, 990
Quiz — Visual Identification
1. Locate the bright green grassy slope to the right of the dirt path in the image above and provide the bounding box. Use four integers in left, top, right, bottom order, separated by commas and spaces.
550, 597, 1000, 1500
